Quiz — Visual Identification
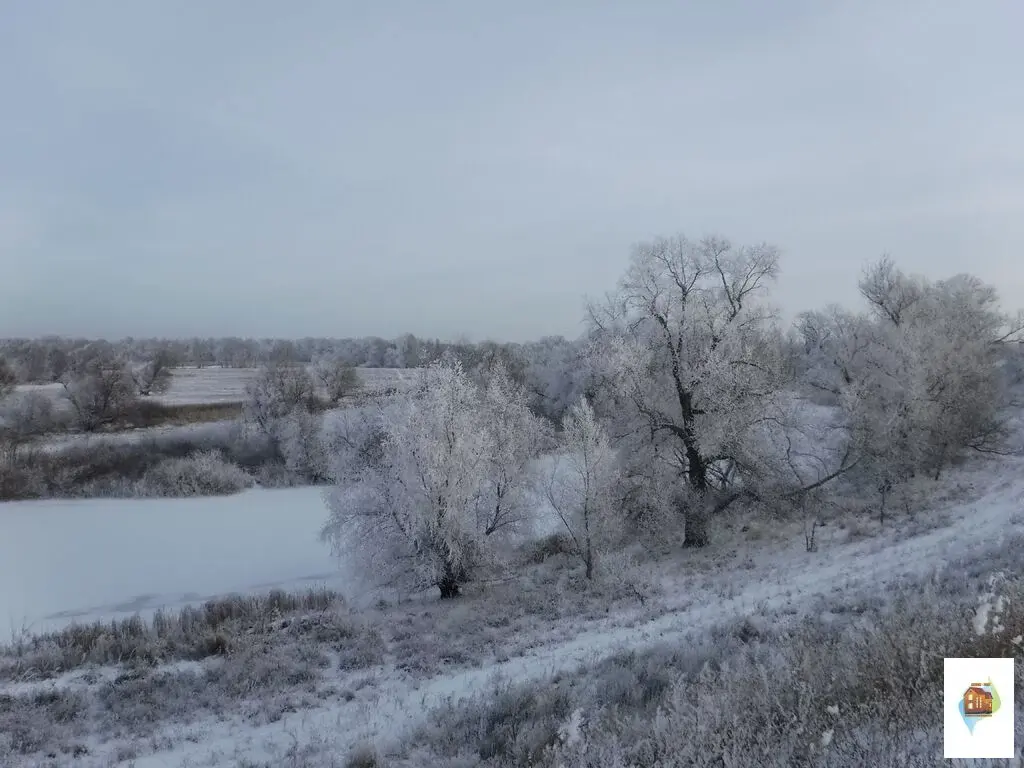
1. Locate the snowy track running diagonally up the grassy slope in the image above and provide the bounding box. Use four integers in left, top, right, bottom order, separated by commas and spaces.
70, 460, 1024, 768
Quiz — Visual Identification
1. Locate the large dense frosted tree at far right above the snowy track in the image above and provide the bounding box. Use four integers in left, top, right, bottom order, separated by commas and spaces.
833, 259, 1024, 489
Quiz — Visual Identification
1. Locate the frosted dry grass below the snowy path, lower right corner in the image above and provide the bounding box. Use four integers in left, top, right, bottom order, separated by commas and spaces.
393, 552, 1024, 768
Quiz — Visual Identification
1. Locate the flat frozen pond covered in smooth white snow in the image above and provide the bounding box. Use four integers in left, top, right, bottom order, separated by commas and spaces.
0, 487, 338, 633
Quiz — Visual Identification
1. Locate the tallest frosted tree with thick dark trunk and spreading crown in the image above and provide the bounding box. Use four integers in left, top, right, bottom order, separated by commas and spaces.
590, 237, 783, 546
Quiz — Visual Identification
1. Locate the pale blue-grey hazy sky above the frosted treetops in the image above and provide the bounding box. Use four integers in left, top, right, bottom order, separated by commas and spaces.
0, 0, 1024, 341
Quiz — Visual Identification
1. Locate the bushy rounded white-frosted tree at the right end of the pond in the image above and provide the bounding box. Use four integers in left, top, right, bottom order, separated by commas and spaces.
323, 362, 532, 598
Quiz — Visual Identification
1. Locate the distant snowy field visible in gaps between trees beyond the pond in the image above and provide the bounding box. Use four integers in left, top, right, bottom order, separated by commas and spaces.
18, 368, 416, 406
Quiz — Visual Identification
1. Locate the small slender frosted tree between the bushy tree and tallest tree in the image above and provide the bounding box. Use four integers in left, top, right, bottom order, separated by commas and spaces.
546, 397, 622, 579
